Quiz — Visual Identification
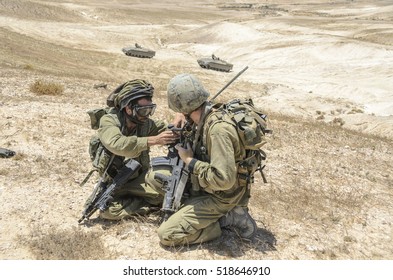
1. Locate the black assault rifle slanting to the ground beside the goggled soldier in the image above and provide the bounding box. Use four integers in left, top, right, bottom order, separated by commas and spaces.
78, 159, 141, 223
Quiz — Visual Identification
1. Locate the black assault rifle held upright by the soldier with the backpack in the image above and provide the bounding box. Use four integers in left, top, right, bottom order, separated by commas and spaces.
151, 124, 189, 221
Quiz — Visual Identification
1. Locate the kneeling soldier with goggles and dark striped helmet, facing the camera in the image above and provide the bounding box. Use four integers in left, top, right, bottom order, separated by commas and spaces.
98, 79, 182, 220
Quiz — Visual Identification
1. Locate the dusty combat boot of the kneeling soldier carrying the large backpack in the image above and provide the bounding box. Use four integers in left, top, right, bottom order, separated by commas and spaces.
218, 206, 257, 239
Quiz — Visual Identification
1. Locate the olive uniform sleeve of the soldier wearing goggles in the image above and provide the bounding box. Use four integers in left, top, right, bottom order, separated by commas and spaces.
98, 114, 148, 158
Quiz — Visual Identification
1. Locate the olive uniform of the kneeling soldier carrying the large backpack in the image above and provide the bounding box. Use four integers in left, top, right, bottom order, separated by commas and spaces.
146, 73, 254, 246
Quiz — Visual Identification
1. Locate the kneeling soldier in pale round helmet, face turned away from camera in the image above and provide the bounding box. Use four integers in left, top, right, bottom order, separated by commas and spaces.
146, 74, 257, 246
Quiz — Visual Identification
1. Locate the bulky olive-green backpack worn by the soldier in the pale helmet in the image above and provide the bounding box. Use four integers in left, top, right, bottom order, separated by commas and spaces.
203, 99, 272, 186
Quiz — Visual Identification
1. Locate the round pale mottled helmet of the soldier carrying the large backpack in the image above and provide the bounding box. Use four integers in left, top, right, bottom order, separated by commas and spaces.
167, 73, 210, 114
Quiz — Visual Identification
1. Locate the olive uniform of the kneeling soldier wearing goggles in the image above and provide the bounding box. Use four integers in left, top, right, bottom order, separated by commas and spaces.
98, 99, 167, 220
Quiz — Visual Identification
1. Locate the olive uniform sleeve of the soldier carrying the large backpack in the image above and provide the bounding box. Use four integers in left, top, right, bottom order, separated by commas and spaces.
193, 123, 239, 191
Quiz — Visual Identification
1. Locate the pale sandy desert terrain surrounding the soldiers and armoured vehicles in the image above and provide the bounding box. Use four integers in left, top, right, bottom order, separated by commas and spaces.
0, 0, 393, 260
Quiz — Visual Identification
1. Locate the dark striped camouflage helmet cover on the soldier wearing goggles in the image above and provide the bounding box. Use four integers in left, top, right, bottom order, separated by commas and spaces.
113, 79, 154, 110
